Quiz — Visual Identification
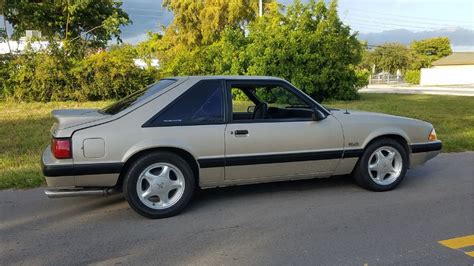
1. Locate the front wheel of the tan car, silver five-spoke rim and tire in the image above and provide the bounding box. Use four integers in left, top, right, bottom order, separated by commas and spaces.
354, 139, 408, 191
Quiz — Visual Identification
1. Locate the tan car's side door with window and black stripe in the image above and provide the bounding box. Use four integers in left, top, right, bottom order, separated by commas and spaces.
225, 81, 343, 183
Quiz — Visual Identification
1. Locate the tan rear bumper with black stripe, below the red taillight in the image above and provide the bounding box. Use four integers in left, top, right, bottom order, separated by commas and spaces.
41, 146, 123, 187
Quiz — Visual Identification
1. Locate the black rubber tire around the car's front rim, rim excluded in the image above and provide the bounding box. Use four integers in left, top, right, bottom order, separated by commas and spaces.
353, 138, 408, 191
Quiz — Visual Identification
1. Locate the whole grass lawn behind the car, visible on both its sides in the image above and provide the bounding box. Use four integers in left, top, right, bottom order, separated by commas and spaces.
0, 94, 474, 189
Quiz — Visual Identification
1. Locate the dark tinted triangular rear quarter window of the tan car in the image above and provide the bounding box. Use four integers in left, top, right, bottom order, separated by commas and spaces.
150, 80, 224, 126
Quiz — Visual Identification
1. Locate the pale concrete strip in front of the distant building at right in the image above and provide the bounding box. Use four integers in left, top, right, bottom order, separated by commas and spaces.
359, 84, 474, 96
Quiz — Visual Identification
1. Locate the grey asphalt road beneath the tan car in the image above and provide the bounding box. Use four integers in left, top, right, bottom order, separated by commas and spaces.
0, 153, 474, 265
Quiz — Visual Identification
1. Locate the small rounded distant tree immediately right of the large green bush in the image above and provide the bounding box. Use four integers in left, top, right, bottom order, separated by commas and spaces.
371, 43, 412, 74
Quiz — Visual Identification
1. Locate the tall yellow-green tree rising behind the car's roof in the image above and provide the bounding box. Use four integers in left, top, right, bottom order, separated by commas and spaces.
155, 0, 274, 76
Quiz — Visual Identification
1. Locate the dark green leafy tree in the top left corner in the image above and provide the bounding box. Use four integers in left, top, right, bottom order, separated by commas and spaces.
4, 0, 131, 47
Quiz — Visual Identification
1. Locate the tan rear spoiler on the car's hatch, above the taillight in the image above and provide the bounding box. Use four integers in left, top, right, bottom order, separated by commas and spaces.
51, 109, 110, 129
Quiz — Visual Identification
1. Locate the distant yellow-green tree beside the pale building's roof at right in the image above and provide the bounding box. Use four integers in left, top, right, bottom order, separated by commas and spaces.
410, 37, 453, 69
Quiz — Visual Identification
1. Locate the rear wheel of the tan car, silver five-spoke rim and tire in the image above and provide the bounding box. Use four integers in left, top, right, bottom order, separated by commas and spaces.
123, 152, 195, 219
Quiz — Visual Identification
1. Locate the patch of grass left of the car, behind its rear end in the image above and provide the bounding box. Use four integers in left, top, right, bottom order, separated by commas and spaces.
0, 102, 107, 189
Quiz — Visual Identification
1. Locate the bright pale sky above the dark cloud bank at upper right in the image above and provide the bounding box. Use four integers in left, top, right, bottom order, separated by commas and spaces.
339, 0, 474, 33
